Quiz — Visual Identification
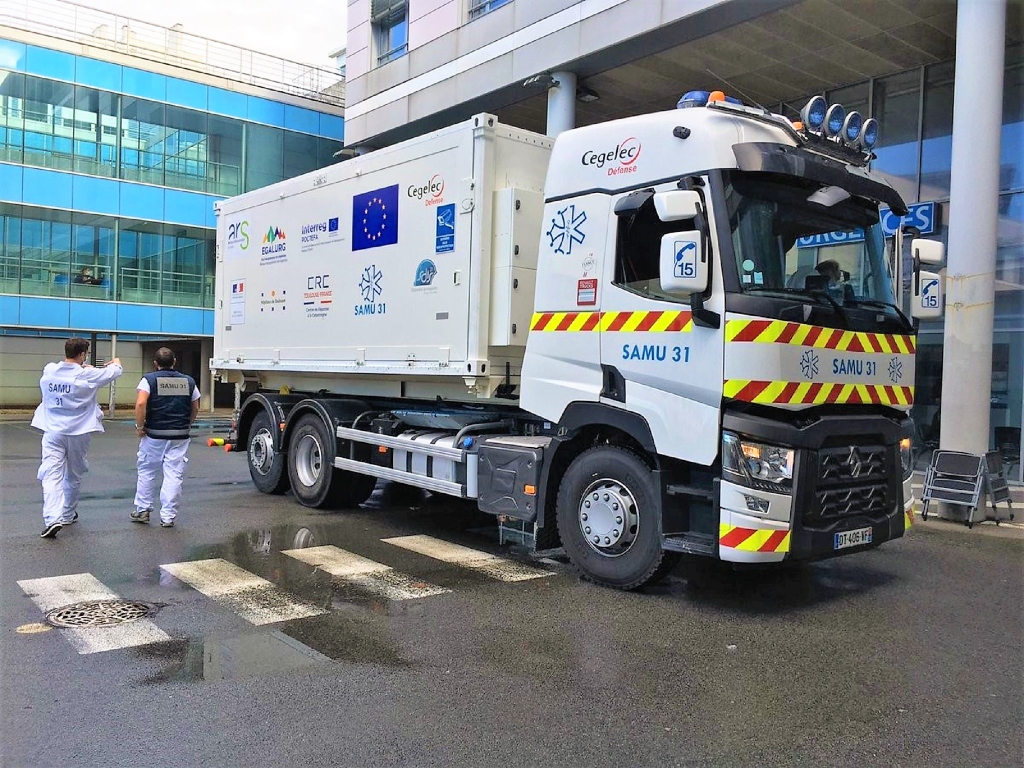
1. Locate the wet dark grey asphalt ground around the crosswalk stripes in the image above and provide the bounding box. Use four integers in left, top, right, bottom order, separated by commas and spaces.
0, 421, 1024, 768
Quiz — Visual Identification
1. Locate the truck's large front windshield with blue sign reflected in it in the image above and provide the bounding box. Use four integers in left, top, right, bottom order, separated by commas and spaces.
725, 171, 894, 308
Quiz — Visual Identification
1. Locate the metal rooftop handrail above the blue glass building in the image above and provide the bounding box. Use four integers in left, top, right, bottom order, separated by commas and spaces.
0, 0, 345, 106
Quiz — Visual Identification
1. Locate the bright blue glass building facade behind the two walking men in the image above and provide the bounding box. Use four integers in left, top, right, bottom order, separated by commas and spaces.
0, 39, 344, 336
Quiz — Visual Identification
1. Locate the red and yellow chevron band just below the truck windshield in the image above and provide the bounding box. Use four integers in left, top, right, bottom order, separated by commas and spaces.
725, 319, 916, 354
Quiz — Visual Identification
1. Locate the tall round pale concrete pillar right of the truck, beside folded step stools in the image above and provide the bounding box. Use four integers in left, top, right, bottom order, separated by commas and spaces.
940, 0, 1007, 455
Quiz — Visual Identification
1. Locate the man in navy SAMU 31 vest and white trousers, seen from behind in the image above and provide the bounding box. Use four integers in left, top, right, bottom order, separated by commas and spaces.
131, 347, 199, 528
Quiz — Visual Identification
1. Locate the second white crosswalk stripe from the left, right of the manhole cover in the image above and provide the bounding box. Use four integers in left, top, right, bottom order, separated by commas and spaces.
160, 557, 327, 625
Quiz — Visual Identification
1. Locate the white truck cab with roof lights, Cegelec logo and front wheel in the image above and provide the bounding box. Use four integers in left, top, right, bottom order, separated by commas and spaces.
521, 93, 941, 583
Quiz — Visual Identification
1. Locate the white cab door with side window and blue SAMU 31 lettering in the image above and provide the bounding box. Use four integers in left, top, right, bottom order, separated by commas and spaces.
600, 186, 724, 465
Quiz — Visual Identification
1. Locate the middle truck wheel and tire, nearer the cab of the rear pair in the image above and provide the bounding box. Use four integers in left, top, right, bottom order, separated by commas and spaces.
288, 414, 377, 509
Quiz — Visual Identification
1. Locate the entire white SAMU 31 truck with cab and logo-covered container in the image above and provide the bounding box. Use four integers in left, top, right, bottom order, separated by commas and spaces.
211, 92, 942, 589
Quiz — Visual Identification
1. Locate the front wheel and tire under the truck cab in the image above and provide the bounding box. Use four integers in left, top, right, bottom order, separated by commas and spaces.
556, 445, 678, 590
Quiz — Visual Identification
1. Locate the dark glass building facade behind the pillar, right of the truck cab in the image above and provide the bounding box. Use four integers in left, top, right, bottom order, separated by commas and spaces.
777, 44, 1024, 479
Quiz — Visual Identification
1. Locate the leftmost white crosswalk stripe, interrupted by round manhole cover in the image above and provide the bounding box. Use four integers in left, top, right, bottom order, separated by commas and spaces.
17, 573, 171, 653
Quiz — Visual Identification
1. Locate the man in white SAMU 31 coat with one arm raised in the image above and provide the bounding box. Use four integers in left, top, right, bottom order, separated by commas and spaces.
32, 338, 124, 539
